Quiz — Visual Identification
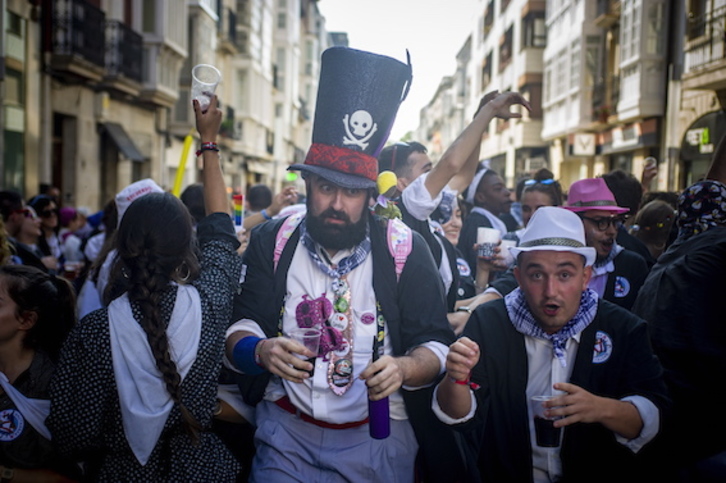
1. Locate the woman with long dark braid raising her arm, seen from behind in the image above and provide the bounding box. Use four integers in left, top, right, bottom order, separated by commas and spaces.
48, 98, 241, 482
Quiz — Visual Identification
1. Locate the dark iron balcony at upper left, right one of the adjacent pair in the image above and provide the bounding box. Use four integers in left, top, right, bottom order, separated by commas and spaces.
104, 20, 144, 95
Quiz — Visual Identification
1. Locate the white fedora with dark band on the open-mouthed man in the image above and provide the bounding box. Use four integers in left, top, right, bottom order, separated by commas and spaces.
509, 206, 596, 265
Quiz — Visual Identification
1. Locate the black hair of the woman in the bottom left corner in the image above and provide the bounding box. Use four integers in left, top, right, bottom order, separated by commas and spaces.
0, 265, 76, 361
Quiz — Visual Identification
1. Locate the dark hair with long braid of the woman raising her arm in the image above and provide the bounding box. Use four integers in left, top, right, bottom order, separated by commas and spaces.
110, 193, 202, 443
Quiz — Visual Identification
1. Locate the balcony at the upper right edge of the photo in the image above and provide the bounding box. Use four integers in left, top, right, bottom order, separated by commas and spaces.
683, 7, 726, 90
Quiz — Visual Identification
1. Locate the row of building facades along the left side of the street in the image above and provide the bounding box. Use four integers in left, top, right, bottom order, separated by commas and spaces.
0, 0, 328, 210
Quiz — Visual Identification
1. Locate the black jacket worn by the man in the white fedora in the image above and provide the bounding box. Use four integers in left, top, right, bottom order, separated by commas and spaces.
459, 300, 669, 483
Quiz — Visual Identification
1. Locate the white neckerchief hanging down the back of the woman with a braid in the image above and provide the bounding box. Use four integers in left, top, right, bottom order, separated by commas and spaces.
108, 285, 202, 465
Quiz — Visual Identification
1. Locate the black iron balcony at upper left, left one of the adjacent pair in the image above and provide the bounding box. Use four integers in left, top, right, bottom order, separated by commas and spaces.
43, 0, 106, 82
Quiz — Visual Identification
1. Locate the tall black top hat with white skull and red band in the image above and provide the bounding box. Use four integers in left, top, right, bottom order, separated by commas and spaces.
288, 47, 412, 188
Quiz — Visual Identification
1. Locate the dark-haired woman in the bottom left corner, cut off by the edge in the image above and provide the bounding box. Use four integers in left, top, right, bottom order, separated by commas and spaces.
0, 265, 76, 481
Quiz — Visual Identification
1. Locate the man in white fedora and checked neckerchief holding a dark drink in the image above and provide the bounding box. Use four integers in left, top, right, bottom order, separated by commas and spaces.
432, 207, 669, 483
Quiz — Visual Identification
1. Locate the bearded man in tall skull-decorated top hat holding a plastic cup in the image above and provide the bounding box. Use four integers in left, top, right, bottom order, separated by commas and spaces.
227, 47, 454, 481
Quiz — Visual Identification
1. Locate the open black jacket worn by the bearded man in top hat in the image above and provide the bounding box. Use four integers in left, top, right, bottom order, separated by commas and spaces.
232, 216, 467, 481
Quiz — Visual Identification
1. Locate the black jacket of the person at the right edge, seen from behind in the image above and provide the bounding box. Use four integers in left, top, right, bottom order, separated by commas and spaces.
633, 227, 726, 466
